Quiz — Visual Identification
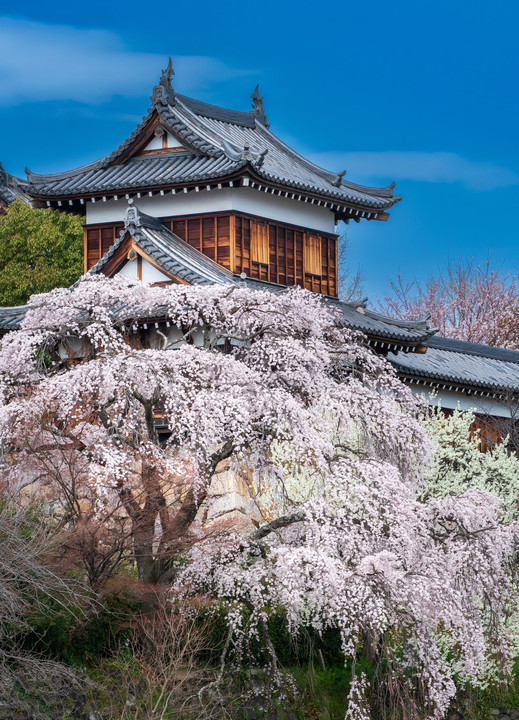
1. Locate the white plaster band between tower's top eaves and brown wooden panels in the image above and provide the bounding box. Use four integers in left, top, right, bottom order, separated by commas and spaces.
85, 185, 335, 233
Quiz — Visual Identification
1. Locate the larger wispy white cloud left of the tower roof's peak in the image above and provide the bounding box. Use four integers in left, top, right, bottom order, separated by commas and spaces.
0, 16, 251, 106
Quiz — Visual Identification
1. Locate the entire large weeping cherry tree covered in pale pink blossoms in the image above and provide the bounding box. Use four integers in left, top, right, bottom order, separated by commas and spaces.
0, 277, 515, 718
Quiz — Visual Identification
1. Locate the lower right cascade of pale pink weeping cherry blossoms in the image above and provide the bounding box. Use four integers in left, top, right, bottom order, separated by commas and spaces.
178, 459, 515, 718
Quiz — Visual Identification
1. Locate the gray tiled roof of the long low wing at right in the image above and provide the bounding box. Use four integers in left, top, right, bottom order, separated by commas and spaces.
389, 336, 519, 394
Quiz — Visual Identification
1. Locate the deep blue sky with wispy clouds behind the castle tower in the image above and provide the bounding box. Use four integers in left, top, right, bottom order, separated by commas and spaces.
0, 0, 519, 298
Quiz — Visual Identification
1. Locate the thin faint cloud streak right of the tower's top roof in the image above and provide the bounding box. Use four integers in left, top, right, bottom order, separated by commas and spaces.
310, 150, 519, 191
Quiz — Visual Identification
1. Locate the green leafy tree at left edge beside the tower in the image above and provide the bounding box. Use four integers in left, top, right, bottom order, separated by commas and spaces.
0, 200, 83, 305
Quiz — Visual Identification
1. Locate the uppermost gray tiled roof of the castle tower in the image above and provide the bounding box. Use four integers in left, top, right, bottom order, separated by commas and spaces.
24, 80, 400, 214
